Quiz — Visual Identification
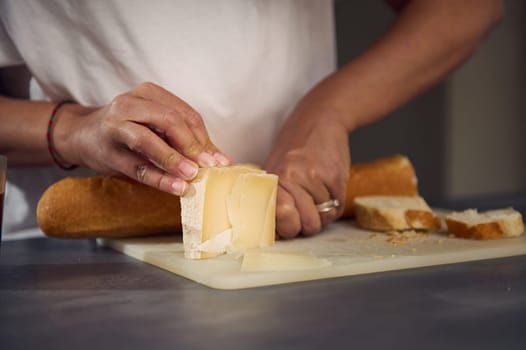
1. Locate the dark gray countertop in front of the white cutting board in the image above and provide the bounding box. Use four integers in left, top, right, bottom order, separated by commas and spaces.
0, 196, 526, 350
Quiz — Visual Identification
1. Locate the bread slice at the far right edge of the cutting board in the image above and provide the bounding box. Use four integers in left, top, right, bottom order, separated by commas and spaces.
446, 208, 524, 239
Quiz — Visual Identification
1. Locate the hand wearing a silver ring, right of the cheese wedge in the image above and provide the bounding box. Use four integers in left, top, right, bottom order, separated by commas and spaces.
265, 96, 351, 238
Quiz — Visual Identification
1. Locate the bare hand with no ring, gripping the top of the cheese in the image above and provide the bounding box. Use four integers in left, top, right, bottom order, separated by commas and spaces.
53, 83, 232, 195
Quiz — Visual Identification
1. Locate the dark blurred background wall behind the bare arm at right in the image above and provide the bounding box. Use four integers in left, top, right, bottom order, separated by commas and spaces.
335, 0, 526, 200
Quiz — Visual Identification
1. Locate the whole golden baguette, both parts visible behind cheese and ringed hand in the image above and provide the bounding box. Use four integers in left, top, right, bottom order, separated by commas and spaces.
37, 155, 418, 238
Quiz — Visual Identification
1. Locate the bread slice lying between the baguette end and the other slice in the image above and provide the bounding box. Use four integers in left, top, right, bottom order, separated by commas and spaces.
354, 196, 441, 231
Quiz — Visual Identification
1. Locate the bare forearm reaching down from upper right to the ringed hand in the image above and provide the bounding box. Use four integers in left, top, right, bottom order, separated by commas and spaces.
300, 0, 502, 131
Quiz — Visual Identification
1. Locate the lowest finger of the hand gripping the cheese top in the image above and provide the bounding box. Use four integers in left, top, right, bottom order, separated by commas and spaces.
107, 149, 189, 196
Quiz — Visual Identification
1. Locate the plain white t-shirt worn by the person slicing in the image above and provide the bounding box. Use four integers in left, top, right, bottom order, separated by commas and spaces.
0, 0, 336, 235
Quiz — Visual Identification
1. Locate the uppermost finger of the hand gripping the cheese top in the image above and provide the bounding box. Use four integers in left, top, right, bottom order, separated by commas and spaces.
131, 83, 232, 166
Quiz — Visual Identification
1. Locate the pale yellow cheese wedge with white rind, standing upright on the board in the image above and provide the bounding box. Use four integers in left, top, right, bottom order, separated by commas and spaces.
181, 166, 278, 259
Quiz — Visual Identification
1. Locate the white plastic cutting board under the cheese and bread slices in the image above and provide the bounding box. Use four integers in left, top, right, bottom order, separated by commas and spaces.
99, 221, 526, 289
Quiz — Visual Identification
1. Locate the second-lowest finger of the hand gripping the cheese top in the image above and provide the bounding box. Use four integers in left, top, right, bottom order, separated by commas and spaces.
114, 123, 198, 180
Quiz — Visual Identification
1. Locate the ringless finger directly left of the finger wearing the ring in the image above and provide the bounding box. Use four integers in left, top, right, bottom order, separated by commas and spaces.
280, 180, 322, 236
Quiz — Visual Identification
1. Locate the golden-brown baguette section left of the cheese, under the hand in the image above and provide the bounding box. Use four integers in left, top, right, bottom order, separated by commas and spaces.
37, 176, 181, 238
